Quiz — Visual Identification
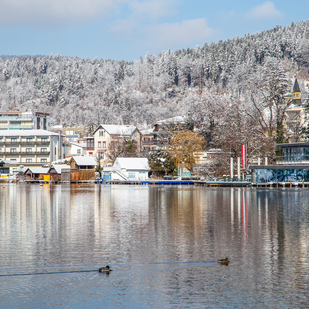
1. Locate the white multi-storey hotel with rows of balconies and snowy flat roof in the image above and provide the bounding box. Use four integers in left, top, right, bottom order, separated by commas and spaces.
0, 130, 63, 167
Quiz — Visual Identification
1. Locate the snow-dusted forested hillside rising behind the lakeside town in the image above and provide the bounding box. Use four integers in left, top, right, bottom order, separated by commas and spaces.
0, 21, 309, 161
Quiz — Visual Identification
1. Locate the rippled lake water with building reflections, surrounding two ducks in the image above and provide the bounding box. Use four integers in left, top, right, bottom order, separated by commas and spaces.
0, 184, 309, 308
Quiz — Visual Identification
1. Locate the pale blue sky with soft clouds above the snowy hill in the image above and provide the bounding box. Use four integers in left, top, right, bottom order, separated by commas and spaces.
0, 0, 309, 61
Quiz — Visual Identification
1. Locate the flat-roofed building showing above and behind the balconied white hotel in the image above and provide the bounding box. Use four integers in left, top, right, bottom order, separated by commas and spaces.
0, 111, 50, 130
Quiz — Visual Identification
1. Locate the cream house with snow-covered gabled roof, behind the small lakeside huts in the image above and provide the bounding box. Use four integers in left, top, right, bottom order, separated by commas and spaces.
93, 124, 142, 163
